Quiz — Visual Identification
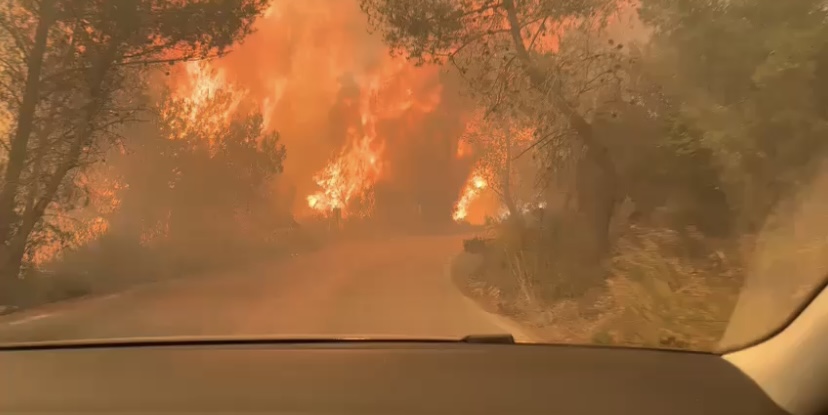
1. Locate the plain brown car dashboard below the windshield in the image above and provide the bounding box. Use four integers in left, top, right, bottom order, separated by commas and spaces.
0, 341, 785, 415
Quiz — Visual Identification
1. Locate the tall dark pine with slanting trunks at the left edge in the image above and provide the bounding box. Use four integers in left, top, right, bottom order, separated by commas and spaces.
0, 0, 267, 300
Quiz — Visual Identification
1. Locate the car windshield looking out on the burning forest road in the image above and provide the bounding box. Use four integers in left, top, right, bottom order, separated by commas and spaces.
0, 0, 828, 350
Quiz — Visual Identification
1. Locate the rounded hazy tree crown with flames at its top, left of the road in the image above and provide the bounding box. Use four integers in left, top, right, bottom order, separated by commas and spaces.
116, 80, 289, 270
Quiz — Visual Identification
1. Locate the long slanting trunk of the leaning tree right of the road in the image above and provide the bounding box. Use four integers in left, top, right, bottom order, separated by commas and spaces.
503, 0, 617, 259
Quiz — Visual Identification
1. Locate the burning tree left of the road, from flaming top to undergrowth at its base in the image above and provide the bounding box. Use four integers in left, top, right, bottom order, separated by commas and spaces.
47, 61, 296, 284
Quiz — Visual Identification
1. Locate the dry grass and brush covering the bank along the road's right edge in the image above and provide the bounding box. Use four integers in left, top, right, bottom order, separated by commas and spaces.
455, 221, 741, 350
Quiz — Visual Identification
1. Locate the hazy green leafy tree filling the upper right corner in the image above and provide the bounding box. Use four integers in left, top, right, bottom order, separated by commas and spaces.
641, 0, 828, 232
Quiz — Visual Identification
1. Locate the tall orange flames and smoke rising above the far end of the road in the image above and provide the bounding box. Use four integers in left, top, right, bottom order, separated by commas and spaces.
172, 0, 492, 226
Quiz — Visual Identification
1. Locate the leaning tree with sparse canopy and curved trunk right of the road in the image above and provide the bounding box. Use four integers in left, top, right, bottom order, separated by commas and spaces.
360, 0, 618, 257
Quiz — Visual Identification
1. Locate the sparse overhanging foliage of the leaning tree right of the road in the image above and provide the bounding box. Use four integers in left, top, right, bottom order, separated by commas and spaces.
360, 0, 620, 114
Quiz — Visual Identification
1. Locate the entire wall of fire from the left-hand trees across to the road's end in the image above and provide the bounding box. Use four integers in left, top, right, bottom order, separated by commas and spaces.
1, 0, 532, 294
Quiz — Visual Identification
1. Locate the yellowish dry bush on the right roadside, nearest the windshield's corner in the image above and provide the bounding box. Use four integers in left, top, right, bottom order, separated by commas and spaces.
605, 226, 741, 349
